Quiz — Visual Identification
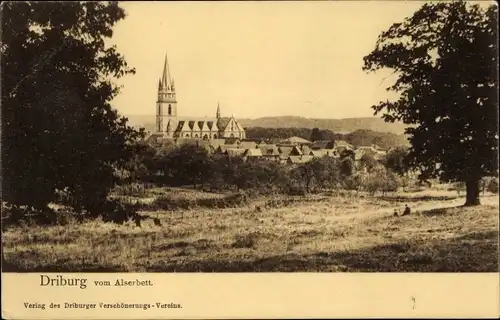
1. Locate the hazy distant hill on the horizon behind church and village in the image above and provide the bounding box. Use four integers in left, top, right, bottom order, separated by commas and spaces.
127, 115, 405, 134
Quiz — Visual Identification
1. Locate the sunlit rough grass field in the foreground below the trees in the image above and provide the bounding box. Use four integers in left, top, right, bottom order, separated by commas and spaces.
3, 191, 499, 272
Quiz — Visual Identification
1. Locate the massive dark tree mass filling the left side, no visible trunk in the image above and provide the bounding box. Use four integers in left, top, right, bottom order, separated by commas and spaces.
0, 1, 141, 218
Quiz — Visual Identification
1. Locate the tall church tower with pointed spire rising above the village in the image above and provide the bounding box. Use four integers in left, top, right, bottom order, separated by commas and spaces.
156, 50, 177, 136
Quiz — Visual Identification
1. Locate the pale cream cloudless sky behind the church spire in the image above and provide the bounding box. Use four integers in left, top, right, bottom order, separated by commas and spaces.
108, 1, 424, 119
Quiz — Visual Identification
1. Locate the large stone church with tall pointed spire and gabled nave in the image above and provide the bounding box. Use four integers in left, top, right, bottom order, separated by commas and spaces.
153, 50, 246, 140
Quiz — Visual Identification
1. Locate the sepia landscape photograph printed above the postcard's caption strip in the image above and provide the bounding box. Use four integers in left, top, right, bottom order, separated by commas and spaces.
0, 1, 499, 276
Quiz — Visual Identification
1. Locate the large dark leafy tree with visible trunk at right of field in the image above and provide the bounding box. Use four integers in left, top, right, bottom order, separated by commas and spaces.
363, 1, 498, 205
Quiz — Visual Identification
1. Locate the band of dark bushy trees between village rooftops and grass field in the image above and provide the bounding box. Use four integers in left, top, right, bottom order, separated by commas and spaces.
120, 143, 434, 198
